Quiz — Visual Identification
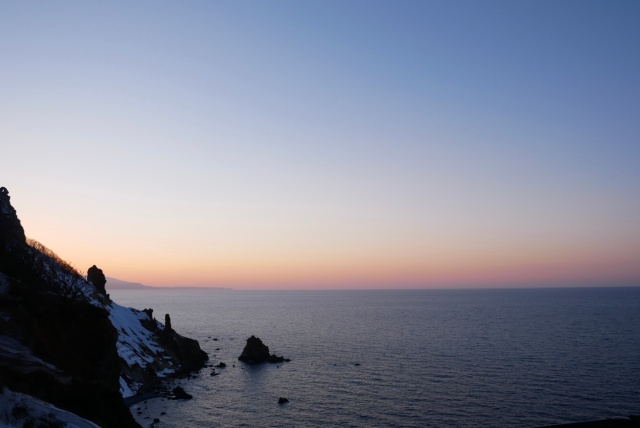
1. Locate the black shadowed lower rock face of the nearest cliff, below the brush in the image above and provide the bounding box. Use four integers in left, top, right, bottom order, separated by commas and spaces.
0, 284, 137, 427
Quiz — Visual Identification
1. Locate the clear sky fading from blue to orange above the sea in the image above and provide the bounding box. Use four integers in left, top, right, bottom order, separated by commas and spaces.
0, 0, 640, 289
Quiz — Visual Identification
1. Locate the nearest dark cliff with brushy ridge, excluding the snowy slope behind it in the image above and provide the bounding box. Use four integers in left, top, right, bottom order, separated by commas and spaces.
0, 187, 138, 427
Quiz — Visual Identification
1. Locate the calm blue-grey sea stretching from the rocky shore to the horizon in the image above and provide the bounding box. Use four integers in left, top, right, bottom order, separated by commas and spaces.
110, 288, 640, 427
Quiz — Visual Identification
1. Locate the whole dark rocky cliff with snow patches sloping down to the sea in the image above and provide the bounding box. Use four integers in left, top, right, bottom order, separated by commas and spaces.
0, 188, 207, 427
